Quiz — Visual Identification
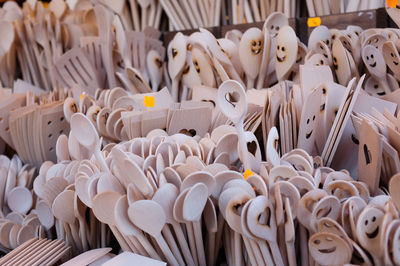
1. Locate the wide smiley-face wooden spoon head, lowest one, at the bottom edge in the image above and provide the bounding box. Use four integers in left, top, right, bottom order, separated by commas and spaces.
308, 232, 352, 265
